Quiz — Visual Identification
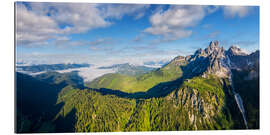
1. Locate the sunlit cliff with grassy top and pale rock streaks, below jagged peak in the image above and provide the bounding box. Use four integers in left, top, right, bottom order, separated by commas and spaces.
163, 76, 233, 130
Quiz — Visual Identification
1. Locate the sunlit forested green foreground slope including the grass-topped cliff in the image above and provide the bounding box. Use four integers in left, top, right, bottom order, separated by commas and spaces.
50, 76, 243, 132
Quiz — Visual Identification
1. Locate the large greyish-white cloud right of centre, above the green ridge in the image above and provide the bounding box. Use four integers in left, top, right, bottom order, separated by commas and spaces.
144, 6, 206, 41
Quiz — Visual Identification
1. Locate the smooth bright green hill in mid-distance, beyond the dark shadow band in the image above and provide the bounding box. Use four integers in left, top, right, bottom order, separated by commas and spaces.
86, 61, 185, 93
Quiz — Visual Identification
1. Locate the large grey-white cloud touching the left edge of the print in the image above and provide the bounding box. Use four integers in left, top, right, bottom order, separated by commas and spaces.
16, 4, 59, 44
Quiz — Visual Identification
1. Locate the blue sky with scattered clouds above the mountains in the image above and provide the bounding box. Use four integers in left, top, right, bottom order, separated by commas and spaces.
16, 2, 259, 65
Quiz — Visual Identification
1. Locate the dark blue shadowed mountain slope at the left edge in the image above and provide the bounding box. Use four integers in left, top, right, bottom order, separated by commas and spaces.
15, 72, 83, 133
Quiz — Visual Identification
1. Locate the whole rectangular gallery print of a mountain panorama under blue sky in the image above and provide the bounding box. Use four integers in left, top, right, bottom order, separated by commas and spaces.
15, 2, 260, 133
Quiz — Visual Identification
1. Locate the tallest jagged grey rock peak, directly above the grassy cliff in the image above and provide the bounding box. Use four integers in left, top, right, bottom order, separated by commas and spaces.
179, 41, 229, 77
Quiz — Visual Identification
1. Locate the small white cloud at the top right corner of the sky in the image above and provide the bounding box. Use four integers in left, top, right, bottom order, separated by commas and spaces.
223, 6, 252, 18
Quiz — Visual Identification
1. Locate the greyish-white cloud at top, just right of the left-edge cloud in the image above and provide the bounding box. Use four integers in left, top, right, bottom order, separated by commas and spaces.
50, 3, 110, 33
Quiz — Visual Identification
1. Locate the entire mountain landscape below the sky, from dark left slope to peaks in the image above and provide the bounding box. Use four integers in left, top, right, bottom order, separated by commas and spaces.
16, 41, 260, 132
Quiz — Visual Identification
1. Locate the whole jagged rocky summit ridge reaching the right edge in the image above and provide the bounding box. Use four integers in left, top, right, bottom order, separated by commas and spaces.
168, 41, 259, 78
